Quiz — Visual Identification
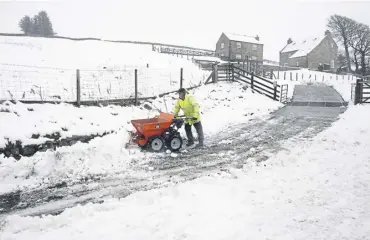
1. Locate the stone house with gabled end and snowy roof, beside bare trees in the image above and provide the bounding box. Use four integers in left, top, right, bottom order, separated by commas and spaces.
280, 31, 338, 72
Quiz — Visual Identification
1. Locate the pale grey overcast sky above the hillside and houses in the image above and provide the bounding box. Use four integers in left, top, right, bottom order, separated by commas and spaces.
0, 0, 370, 60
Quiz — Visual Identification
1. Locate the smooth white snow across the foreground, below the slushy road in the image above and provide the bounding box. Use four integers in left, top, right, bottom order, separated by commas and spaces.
0, 105, 370, 240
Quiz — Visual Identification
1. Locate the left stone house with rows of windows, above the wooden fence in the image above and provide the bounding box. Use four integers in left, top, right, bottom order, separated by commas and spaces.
215, 33, 263, 62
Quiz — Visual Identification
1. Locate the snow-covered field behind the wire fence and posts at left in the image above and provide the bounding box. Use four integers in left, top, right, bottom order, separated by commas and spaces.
0, 37, 210, 101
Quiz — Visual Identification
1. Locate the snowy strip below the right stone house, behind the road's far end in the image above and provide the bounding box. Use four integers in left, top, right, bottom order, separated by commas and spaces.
274, 69, 356, 102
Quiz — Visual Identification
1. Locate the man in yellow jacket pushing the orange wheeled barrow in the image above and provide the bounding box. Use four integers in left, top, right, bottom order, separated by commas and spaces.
174, 88, 204, 147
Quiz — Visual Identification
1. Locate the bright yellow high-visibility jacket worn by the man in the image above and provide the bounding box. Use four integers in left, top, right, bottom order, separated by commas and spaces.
174, 94, 200, 125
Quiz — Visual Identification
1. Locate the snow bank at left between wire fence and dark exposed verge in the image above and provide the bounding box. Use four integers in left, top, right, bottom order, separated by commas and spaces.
0, 102, 148, 148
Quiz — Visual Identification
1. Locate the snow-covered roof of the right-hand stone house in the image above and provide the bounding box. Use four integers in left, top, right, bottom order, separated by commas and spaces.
281, 36, 325, 58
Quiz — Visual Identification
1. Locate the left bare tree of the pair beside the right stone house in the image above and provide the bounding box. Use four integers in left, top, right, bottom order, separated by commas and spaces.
327, 15, 356, 72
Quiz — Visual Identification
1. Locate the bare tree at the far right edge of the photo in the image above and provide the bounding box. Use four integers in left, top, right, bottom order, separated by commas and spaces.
349, 23, 370, 75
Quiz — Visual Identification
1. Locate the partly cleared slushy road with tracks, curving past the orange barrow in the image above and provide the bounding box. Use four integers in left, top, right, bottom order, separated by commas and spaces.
2, 85, 346, 218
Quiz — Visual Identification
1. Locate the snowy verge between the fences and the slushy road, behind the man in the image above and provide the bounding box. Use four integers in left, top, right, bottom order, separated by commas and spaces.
0, 83, 282, 192
